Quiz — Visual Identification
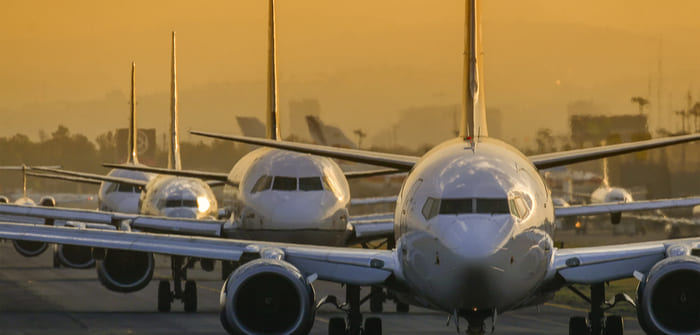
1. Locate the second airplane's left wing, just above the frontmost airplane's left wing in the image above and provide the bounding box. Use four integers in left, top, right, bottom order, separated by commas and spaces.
0, 204, 225, 237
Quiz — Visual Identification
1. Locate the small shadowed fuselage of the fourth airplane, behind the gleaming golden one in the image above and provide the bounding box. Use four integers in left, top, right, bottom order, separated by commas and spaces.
97, 164, 155, 214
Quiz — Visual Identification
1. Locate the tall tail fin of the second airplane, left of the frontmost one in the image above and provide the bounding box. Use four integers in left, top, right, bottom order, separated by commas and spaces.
265, 0, 282, 140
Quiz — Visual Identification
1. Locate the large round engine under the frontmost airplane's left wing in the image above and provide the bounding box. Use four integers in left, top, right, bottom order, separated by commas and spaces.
220, 259, 316, 334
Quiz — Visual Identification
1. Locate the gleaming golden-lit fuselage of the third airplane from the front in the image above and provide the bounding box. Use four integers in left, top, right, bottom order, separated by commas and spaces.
138, 175, 218, 219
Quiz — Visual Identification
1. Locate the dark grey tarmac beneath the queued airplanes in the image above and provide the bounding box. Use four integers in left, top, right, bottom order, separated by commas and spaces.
0, 241, 643, 335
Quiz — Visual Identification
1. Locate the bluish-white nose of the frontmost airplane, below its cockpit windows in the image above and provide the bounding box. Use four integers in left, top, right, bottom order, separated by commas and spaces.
436, 214, 513, 260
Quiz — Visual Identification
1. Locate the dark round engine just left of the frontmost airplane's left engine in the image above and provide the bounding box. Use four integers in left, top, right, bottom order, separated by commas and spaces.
97, 249, 155, 293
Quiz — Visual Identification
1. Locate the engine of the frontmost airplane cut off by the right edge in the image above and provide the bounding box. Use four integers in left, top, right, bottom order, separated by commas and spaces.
637, 256, 700, 335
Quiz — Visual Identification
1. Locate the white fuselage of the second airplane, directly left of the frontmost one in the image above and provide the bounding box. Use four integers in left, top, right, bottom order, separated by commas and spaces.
224, 148, 350, 245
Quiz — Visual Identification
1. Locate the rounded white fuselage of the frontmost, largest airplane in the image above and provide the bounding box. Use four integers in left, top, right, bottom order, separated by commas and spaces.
395, 138, 554, 315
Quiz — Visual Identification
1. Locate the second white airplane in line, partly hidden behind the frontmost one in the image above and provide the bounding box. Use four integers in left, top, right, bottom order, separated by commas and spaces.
104, 4, 398, 252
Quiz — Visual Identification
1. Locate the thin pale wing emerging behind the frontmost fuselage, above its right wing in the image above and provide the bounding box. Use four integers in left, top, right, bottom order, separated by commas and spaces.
554, 197, 700, 217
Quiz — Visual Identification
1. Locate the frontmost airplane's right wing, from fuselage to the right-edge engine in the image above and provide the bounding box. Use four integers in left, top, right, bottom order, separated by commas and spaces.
549, 238, 700, 284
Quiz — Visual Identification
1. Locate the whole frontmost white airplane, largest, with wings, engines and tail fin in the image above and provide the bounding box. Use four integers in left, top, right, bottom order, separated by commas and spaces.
0, 0, 700, 335
